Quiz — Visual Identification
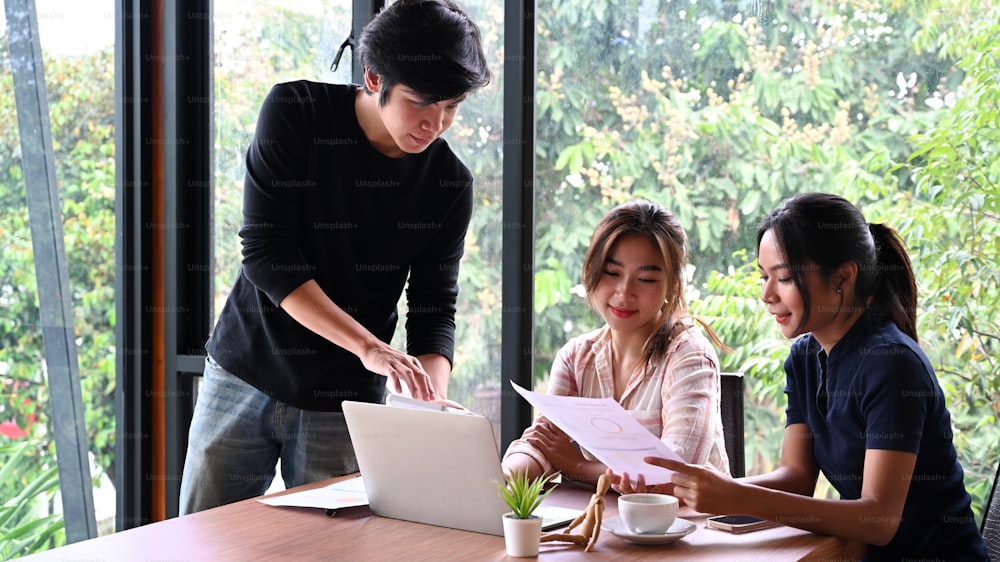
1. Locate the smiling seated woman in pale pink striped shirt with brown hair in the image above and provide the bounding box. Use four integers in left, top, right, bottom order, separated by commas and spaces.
503, 201, 729, 492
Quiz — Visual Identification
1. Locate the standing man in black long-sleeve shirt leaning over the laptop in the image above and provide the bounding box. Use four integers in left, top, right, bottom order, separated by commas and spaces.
180, 0, 491, 514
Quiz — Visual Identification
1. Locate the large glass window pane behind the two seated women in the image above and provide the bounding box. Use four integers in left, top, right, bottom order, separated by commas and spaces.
535, 0, 1000, 514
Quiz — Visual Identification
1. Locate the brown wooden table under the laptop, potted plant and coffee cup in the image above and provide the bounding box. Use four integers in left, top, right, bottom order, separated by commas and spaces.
21, 472, 864, 562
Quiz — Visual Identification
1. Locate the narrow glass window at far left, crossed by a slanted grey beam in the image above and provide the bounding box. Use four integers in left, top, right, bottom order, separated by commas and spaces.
0, 0, 115, 559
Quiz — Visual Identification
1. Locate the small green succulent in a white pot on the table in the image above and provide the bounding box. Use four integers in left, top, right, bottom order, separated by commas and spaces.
497, 471, 555, 557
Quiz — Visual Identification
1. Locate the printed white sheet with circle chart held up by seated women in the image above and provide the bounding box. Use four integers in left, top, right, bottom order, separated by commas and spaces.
510, 381, 684, 484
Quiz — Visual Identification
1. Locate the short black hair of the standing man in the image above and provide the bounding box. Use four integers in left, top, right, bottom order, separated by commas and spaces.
357, 0, 492, 105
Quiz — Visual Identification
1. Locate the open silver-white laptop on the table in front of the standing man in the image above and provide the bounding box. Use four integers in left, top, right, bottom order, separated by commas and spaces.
343, 401, 581, 535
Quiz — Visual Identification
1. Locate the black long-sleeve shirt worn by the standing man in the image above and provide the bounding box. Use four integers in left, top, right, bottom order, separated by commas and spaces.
206, 81, 472, 411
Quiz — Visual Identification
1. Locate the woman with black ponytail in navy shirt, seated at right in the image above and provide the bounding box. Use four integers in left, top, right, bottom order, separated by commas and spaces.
614, 193, 988, 561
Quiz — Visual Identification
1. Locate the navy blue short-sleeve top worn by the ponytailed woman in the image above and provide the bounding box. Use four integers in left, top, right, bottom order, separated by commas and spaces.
785, 314, 987, 560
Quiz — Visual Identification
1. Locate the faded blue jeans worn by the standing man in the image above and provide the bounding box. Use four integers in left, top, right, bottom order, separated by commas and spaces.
180, 357, 358, 515
